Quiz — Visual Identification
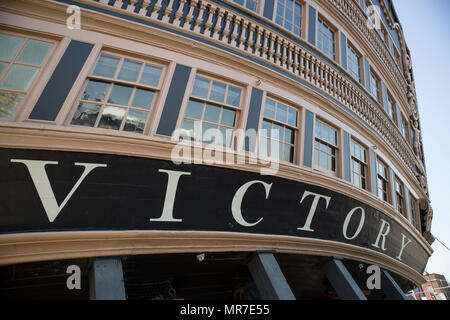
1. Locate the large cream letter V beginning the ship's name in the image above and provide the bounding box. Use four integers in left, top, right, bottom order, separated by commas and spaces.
11, 159, 107, 222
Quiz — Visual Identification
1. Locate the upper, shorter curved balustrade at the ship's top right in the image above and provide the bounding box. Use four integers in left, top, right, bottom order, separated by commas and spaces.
327, 0, 408, 107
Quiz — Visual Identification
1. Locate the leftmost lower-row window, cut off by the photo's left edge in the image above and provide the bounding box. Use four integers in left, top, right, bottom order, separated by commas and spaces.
0, 34, 53, 118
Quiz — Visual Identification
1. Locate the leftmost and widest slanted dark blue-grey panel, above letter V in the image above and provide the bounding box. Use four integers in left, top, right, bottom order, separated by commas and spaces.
29, 41, 94, 121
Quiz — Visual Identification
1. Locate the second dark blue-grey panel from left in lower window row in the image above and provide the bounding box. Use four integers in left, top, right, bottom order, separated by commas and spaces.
157, 64, 191, 136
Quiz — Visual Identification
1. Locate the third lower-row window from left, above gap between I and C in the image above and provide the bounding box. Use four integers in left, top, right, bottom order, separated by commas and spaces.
181, 76, 242, 147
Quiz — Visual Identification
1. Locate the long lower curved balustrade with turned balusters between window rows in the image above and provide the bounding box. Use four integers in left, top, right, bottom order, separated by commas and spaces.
78, 0, 415, 175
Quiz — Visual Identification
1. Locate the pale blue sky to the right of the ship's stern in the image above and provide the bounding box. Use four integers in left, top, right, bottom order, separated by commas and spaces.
394, 0, 450, 281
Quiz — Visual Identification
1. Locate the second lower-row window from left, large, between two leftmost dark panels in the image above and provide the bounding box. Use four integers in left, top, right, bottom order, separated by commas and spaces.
71, 53, 163, 133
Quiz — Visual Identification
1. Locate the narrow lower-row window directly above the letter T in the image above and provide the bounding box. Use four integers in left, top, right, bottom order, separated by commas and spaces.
314, 120, 338, 173
